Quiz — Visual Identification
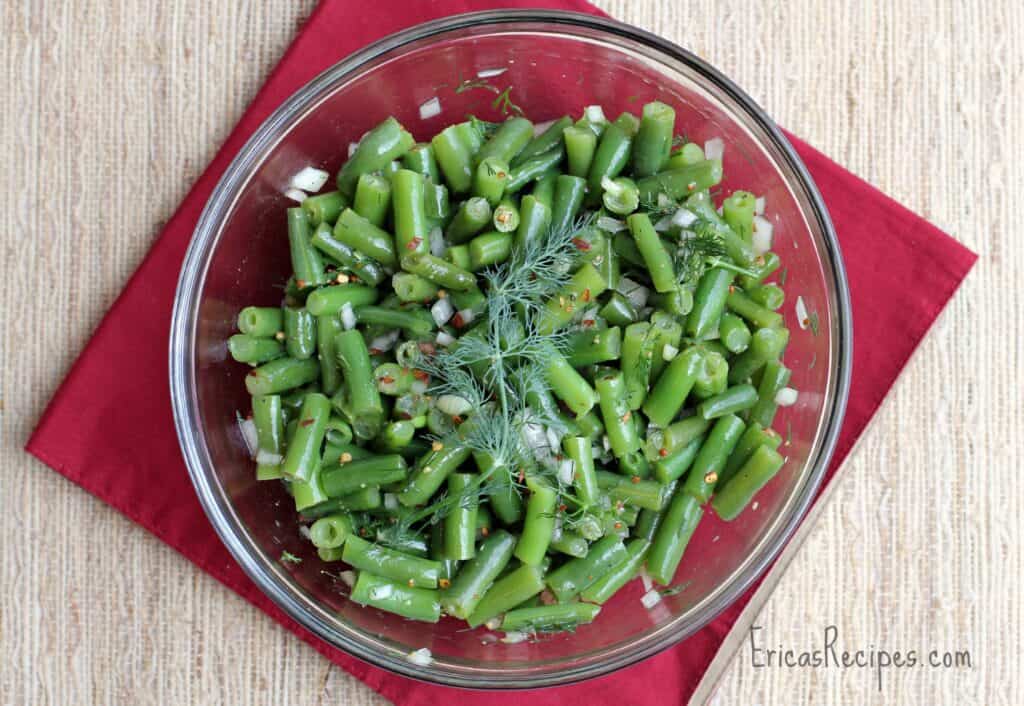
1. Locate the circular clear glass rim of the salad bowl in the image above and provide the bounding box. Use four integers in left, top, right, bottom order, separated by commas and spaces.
169, 9, 853, 690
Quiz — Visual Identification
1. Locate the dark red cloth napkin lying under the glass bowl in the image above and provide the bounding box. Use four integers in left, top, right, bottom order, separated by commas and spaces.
27, 0, 976, 706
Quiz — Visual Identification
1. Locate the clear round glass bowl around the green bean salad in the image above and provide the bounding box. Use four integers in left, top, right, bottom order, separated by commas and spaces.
170, 10, 851, 689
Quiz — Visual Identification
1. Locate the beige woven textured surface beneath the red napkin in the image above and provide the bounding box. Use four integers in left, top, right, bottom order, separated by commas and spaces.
0, 3, 1021, 703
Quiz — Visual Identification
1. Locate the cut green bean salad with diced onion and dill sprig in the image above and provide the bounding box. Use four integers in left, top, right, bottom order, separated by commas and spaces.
234, 101, 797, 639
